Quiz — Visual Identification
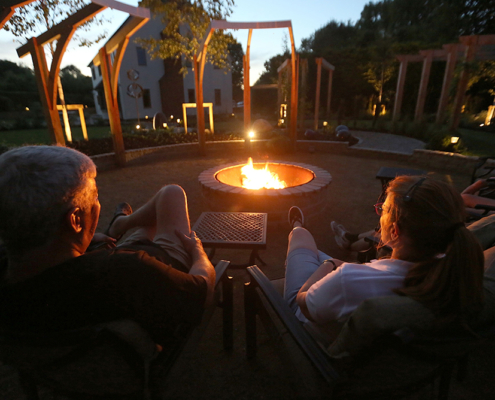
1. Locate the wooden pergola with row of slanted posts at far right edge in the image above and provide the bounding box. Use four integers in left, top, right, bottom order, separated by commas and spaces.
393, 35, 495, 130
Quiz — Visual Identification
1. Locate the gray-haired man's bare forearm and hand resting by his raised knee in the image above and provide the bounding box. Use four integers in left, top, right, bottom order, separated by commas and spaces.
175, 231, 215, 307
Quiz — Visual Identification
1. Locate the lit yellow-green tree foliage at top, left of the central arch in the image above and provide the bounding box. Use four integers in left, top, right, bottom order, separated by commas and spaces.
137, 0, 235, 75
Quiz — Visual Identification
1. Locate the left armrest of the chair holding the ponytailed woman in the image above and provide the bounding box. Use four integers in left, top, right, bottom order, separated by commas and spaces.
245, 265, 339, 383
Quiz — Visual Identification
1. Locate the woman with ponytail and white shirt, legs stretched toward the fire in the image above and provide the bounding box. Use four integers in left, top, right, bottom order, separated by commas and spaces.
285, 176, 483, 334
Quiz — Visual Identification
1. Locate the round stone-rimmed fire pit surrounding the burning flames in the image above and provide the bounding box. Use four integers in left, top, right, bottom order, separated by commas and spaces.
198, 161, 332, 224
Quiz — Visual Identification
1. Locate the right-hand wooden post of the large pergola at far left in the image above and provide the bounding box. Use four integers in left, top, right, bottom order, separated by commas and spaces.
99, 47, 126, 167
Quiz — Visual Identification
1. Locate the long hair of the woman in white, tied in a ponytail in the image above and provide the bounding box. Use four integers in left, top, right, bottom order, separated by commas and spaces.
388, 176, 484, 324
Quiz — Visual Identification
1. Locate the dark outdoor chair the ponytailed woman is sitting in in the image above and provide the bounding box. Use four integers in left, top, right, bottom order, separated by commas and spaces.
244, 266, 488, 399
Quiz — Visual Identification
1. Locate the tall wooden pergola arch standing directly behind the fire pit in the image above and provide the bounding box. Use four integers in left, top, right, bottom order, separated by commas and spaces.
194, 20, 298, 154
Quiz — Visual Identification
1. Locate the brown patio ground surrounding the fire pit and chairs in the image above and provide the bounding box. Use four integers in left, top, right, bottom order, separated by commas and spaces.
0, 138, 495, 399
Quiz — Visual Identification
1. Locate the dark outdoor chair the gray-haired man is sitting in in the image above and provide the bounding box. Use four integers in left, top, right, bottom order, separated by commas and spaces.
0, 261, 233, 400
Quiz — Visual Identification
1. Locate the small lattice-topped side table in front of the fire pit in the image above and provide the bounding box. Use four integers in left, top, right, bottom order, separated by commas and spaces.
192, 211, 268, 268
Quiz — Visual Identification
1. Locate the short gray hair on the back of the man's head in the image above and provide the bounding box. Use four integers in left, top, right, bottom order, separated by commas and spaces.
0, 146, 96, 254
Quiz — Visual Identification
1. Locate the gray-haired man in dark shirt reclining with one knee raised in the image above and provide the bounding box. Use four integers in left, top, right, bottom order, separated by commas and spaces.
0, 146, 215, 346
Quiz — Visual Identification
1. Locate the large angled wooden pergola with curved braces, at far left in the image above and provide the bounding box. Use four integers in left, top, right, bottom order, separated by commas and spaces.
10, 0, 150, 166
